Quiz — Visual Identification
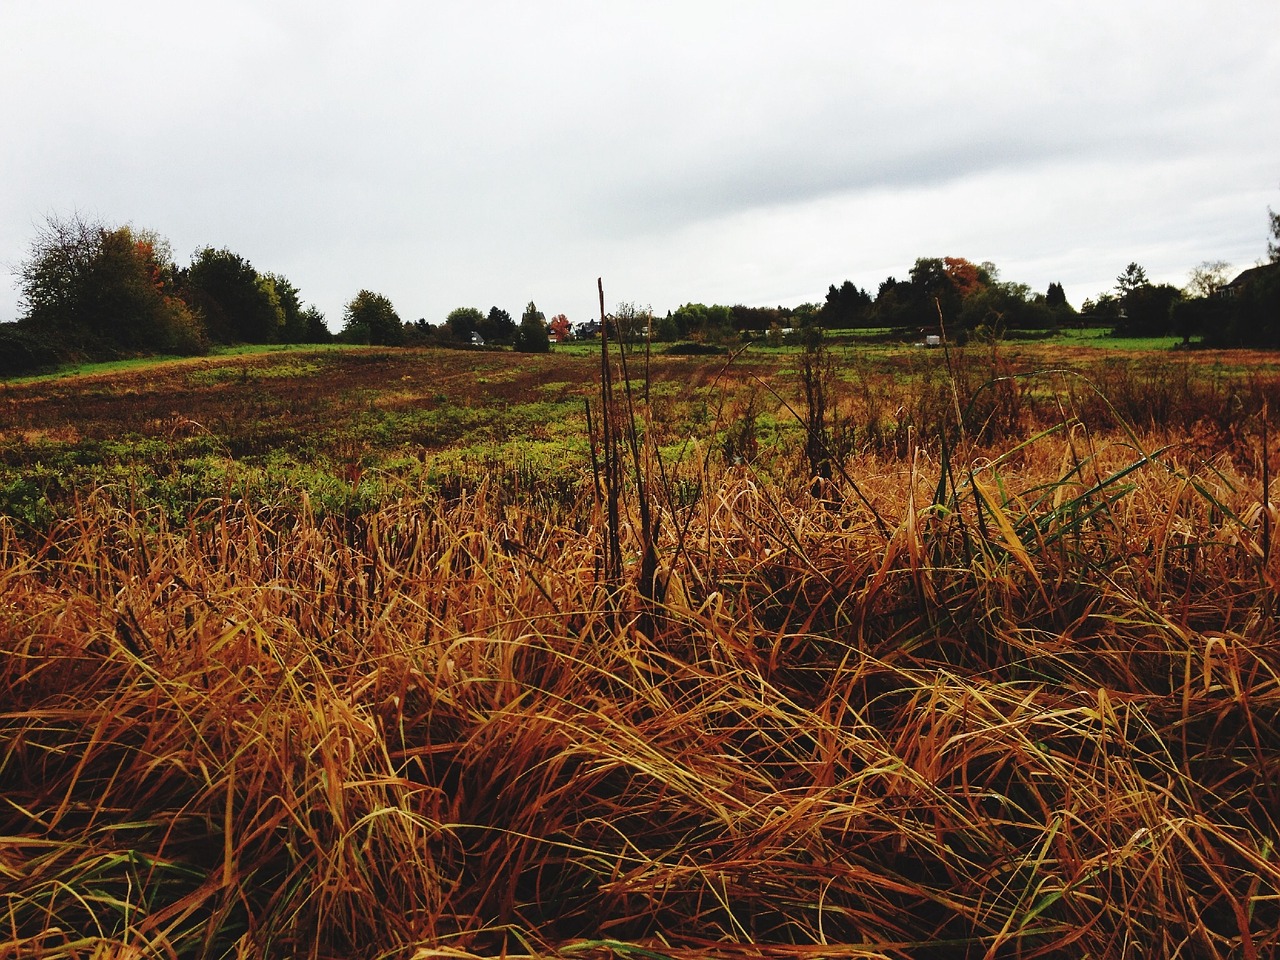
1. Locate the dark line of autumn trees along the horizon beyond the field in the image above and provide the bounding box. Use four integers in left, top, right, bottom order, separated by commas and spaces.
0, 211, 1280, 376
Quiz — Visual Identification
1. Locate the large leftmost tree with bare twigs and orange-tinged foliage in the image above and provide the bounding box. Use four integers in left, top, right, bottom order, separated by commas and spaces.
18, 216, 207, 355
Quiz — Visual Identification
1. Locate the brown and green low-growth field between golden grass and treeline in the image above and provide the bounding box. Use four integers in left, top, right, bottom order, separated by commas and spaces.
0, 338, 1276, 521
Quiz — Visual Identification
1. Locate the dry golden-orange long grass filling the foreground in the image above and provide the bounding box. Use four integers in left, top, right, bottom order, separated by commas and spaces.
0, 404, 1280, 959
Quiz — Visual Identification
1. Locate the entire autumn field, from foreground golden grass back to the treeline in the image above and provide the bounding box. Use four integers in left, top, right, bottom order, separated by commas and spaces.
0, 347, 1280, 960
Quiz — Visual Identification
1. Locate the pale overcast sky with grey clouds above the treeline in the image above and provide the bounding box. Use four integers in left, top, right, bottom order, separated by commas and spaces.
0, 0, 1280, 329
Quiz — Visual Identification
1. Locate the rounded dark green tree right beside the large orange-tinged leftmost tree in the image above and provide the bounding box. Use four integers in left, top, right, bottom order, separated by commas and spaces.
184, 247, 284, 343
